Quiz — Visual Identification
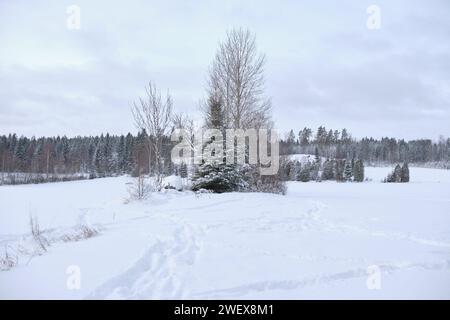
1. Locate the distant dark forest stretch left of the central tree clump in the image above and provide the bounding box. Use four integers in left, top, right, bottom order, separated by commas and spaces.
0, 131, 174, 181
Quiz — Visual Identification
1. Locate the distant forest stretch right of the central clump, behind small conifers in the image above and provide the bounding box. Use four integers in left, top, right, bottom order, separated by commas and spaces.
280, 126, 450, 168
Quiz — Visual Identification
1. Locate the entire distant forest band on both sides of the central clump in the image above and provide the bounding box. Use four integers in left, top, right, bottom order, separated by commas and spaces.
0, 127, 450, 184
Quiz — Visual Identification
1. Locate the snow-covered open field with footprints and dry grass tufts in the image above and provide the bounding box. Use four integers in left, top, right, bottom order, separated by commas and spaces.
0, 168, 450, 299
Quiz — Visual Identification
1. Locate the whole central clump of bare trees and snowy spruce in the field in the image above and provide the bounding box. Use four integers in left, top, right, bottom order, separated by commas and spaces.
123, 29, 285, 193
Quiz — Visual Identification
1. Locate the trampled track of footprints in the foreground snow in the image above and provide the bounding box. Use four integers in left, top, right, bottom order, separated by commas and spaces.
87, 219, 206, 299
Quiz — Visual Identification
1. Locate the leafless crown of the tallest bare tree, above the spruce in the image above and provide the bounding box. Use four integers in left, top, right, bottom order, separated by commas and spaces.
208, 29, 271, 129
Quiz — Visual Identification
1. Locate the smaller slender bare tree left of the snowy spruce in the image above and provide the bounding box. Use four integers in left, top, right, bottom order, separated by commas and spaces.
131, 82, 172, 191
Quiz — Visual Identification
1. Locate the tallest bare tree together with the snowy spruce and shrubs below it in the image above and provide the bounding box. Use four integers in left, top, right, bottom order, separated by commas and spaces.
187, 29, 286, 193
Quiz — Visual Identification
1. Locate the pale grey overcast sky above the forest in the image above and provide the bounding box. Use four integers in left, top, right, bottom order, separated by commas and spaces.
0, 0, 450, 139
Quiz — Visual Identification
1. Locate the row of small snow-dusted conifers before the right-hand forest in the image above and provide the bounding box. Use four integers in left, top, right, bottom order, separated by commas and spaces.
281, 156, 364, 182
